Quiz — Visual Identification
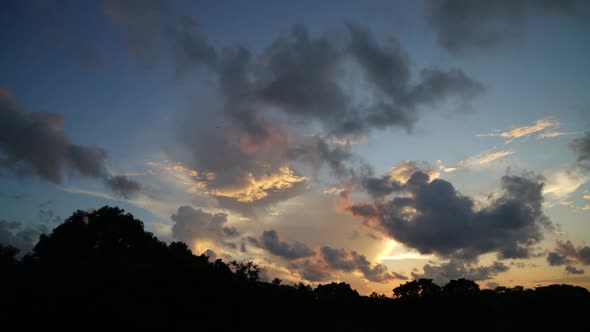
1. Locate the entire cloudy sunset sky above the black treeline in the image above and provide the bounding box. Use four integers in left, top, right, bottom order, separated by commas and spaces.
0, 0, 590, 295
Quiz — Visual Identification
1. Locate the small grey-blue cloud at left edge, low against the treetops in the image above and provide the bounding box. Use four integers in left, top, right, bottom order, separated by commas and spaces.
0, 220, 49, 255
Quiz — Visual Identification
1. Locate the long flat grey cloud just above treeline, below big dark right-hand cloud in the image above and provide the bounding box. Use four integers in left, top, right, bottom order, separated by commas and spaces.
412, 260, 510, 285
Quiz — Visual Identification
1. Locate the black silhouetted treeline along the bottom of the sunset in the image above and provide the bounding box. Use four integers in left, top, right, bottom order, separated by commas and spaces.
0, 207, 590, 331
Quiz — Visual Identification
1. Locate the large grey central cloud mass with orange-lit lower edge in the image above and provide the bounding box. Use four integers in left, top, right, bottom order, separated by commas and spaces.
104, 9, 484, 215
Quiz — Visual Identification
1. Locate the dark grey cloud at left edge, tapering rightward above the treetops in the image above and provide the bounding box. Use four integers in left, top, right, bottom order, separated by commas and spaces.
0, 91, 140, 196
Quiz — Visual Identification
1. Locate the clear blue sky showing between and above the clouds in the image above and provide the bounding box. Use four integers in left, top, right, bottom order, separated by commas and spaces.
0, 0, 590, 228
